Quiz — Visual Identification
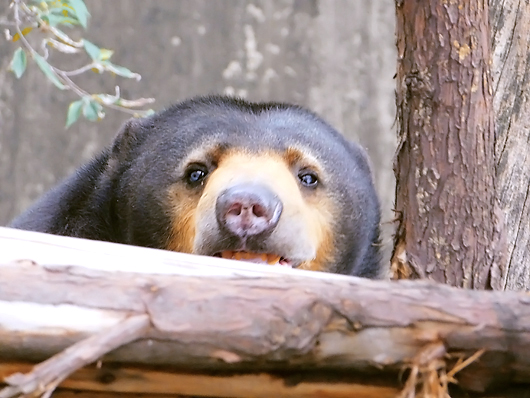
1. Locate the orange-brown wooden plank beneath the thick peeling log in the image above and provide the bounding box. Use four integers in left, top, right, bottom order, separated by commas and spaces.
0, 363, 399, 398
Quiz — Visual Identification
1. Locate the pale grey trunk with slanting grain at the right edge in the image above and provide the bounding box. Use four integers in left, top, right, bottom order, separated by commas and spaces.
490, 0, 530, 290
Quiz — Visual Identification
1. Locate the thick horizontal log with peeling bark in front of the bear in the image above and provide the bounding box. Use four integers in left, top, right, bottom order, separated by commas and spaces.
0, 228, 530, 397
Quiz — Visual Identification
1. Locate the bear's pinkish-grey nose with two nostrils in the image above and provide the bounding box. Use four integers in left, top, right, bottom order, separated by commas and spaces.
215, 184, 283, 238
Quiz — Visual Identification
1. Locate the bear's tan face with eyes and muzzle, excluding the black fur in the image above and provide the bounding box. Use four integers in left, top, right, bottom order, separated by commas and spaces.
168, 144, 336, 270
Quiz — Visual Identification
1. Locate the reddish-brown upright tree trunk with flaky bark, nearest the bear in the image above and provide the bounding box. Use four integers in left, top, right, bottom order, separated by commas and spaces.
392, 0, 504, 289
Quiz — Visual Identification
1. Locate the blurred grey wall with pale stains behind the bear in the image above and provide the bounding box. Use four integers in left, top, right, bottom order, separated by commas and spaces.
0, 0, 395, 252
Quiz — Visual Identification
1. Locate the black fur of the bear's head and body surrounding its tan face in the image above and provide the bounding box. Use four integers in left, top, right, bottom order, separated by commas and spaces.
11, 96, 380, 278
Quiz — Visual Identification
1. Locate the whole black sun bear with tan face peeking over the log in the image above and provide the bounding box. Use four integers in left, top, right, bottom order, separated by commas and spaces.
11, 96, 381, 278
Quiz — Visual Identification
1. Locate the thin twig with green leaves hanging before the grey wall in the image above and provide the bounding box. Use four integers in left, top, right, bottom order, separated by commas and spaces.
2, 0, 154, 127
